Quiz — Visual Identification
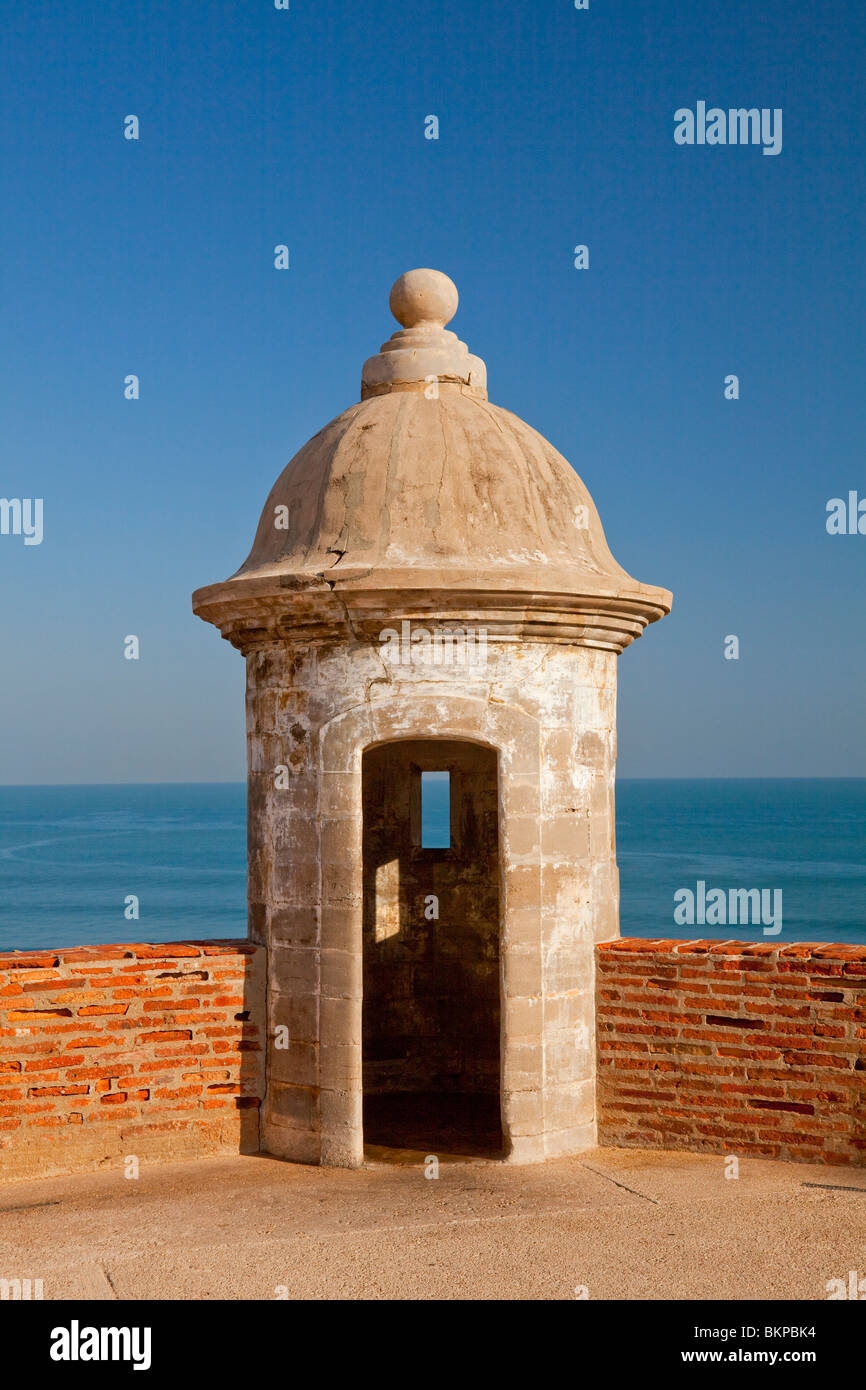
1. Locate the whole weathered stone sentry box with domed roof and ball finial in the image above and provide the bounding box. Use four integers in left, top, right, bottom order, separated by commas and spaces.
193, 271, 670, 1166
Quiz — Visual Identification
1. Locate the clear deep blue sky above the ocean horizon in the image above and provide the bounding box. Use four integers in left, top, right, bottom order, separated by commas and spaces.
0, 0, 866, 783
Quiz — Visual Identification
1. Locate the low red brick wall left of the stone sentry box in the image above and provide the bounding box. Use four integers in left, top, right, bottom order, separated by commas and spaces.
0, 941, 264, 1182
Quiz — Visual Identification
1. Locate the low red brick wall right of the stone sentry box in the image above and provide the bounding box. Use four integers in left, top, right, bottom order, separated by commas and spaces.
598, 940, 866, 1163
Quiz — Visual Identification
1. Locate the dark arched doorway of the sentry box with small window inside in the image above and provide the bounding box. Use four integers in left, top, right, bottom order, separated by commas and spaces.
361, 738, 502, 1155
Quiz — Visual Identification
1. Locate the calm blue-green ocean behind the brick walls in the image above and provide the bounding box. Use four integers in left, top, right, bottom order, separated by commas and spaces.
0, 778, 866, 951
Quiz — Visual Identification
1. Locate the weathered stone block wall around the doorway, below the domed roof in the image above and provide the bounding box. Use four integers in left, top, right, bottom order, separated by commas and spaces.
247, 636, 619, 1168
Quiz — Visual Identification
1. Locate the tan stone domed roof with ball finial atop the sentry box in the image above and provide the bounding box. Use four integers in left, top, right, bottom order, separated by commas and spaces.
193, 270, 671, 651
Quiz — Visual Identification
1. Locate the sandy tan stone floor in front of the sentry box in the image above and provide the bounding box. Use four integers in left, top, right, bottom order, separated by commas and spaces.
0, 1148, 866, 1300
